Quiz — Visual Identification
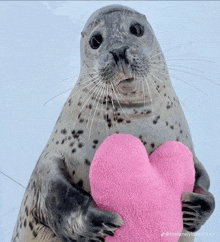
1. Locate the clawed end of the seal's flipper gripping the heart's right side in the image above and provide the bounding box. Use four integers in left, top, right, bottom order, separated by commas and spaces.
182, 189, 215, 232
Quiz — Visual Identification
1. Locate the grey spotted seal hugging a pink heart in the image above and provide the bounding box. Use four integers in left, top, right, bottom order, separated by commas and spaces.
12, 5, 215, 242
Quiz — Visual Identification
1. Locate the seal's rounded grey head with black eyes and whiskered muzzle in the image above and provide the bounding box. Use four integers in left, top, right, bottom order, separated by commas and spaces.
81, 5, 169, 106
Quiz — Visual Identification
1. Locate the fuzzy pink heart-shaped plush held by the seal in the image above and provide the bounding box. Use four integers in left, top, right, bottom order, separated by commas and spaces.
90, 134, 195, 242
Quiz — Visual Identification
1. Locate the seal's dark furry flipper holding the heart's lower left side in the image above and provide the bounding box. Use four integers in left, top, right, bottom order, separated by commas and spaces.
45, 156, 122, 242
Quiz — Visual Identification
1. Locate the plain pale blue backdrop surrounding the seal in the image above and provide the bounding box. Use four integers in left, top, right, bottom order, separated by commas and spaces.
0, 1, 220, 242
